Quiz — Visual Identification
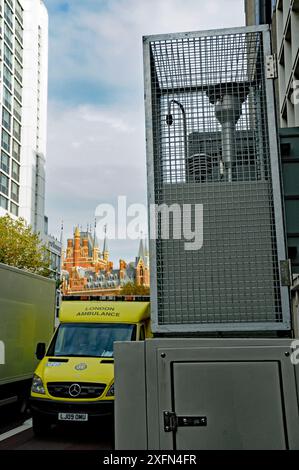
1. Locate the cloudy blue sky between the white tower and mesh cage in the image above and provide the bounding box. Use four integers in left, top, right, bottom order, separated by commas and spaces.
44, 0, 244, 263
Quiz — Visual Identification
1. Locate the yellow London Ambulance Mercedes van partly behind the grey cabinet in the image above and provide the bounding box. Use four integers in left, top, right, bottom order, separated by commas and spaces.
30, 300, 150, 435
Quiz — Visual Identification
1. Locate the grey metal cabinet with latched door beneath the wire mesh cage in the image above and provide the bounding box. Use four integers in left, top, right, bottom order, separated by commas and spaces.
115, 339, 299, 450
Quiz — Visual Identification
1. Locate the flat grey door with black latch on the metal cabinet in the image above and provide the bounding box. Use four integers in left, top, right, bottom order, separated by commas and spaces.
173, 362, 286, 449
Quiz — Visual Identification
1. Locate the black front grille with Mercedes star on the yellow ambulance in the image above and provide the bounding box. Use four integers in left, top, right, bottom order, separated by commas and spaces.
47, 382, 106, 399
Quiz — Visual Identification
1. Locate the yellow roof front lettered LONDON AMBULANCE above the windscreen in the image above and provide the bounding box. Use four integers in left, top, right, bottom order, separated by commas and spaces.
59, 300, 150, 323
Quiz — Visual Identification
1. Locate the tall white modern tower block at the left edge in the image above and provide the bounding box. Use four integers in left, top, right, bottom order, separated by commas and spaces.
0, 0, 48, 238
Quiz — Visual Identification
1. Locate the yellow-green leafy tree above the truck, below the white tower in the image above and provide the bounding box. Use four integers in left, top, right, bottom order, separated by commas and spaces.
0, 215, 51, 277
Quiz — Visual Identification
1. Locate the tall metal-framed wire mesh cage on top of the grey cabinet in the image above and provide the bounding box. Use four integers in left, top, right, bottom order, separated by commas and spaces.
144, 27, 290, 332
